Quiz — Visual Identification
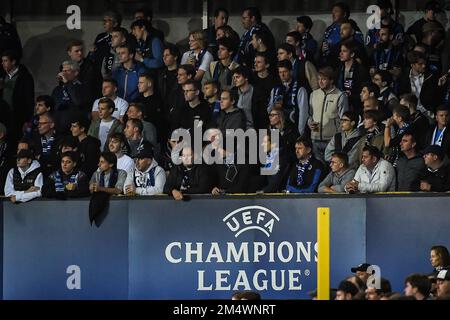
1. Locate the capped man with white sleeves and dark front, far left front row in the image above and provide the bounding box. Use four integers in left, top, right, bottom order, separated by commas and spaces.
5, 150, 44, 203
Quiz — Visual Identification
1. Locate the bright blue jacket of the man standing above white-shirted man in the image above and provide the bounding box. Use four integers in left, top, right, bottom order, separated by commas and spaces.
112, 61, 146, 102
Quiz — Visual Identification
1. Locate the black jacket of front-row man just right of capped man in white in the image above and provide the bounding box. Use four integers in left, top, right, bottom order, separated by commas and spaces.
164, 165, 215, 196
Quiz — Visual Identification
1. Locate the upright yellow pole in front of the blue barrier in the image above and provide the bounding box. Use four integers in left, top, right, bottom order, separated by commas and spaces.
317, 208, 330, 300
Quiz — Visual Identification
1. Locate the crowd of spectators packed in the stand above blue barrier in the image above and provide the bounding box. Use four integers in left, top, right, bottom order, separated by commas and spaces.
0, 0, 450, 204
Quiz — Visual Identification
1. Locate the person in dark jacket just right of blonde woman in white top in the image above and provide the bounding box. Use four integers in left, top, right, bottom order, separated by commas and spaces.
202, 38, 239, 88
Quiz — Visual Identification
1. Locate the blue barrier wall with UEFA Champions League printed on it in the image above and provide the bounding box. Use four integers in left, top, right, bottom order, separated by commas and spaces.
2, 197, 450, 299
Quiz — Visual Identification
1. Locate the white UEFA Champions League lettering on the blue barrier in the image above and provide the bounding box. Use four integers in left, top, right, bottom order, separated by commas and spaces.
165, 206, 318, 291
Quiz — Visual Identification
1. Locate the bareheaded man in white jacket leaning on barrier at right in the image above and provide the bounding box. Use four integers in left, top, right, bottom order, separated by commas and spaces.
345, 146, 395, 193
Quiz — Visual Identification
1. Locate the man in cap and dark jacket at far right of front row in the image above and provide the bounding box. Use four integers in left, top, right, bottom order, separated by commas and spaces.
413, 145, 450, 192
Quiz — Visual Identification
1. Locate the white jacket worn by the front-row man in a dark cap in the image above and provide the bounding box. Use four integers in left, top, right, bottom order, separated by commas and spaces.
124, 159, 166, 196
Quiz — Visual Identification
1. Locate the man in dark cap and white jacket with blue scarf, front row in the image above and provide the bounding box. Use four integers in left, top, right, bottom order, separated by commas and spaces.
124, 141, 166, 196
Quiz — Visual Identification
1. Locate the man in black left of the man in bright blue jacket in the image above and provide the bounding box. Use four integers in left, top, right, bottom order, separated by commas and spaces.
67, 40, 102, 105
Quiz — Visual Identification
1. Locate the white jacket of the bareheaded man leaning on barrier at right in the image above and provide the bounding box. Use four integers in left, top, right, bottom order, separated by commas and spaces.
354, 159, 395, 193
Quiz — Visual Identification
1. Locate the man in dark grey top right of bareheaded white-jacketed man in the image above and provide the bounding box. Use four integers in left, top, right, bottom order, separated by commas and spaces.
396, 133, 425, 191
